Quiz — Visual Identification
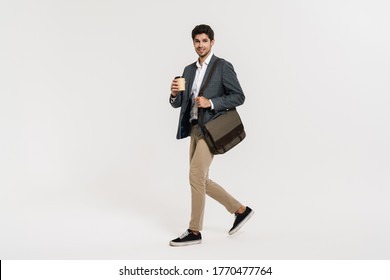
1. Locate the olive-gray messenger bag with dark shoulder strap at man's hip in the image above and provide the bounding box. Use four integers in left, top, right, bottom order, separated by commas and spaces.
199, 59, 246, 155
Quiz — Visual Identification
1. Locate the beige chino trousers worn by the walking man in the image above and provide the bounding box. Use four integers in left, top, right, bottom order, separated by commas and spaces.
189, 125, 242, 231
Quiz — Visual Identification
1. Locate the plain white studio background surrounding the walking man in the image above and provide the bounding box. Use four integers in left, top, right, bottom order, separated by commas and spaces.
0, 0, 390, 259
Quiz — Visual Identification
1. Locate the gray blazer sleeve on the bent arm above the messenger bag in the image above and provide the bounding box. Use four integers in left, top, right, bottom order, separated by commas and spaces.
212, 60, 245, 112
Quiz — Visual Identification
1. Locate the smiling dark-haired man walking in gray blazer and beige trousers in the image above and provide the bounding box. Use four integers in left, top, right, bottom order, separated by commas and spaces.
169, 25, 254, 246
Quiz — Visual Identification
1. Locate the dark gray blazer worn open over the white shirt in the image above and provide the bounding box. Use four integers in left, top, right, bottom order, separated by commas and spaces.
169, 55, 245, 139
